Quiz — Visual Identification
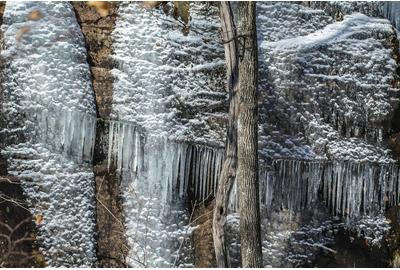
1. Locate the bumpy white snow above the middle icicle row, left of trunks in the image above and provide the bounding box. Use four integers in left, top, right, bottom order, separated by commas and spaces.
112, 3, 227, 146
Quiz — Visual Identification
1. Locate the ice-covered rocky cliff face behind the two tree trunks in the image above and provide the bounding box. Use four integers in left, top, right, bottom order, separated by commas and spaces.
0, 2, 400, 267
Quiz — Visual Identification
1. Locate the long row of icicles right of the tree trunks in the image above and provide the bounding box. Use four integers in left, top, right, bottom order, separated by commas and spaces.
260, 160, 400, 218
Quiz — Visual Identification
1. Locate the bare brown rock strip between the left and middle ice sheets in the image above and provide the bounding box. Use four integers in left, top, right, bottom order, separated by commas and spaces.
72, 2, 128, 267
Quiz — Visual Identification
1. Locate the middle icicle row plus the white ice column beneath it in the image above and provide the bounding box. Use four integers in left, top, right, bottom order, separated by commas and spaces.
108, 121, 223, 267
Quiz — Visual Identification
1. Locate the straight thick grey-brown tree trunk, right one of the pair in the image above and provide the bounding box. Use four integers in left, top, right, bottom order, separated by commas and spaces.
236, 2, 263, 267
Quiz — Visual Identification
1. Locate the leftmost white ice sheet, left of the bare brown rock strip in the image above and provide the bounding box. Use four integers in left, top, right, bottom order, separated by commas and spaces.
0, 2, 96, 267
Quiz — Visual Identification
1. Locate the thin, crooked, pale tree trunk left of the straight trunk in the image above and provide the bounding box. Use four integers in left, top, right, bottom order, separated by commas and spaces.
213, 2, 238, 267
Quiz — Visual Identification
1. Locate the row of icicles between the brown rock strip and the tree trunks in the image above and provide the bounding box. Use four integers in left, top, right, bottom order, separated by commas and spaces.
108, 121, 224, 202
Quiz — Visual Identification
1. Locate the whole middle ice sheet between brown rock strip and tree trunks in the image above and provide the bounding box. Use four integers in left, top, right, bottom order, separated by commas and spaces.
108, 2, 226, 267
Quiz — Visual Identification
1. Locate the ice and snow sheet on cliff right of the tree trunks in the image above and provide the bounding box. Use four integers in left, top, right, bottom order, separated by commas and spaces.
230, 3, 399, 267
